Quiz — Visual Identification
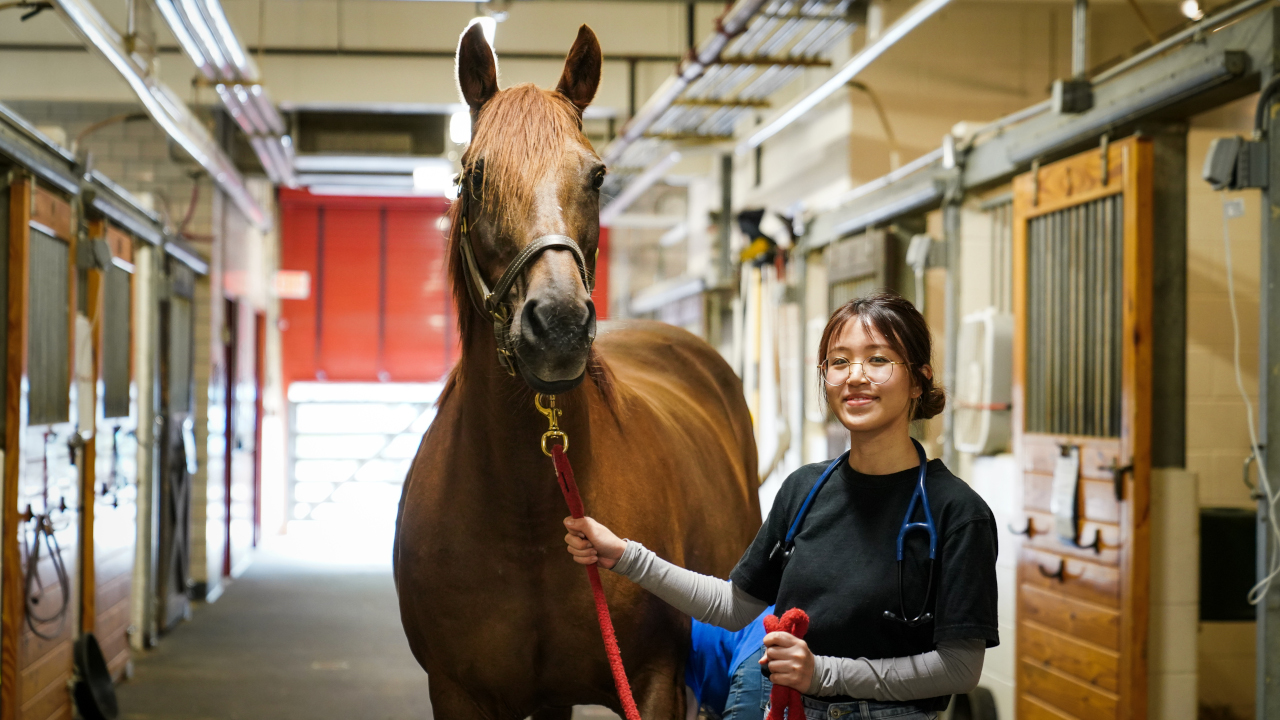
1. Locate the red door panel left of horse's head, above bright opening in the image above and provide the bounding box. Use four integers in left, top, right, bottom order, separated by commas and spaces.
280, 190, 457, 382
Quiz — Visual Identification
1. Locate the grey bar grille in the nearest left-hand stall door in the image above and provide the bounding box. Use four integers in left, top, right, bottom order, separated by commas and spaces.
27, 228, 70, 425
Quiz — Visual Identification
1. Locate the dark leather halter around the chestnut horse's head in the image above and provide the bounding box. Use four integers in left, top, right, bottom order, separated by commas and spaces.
458, 165, 594, 375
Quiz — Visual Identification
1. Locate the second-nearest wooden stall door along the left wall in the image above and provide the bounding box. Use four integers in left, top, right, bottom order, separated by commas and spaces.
81, 222, 137, 679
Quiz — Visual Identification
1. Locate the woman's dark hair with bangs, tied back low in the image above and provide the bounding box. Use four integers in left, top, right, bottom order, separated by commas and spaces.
818, 291, 947, 420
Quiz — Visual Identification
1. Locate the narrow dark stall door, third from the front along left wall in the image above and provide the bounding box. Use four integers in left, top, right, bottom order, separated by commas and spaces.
156, 259, 196, 632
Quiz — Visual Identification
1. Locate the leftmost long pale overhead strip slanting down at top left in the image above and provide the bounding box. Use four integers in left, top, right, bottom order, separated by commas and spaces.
54, 0, 270, 231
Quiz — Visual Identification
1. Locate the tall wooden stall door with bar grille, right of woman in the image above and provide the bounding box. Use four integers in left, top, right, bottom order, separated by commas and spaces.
1014, 138, 1152, 720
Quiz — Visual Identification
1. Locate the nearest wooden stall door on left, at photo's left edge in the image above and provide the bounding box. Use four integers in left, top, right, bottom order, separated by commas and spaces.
0, 179, 82, 720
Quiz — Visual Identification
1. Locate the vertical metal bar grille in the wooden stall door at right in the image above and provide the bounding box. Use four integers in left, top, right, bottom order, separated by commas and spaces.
1025, 195, 1124, 437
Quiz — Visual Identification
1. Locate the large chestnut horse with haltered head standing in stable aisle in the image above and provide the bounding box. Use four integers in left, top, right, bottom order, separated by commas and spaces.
394, 26, 760, 720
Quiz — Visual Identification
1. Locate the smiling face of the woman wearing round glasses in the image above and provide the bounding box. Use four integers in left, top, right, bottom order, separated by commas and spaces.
823, 316, 929, 433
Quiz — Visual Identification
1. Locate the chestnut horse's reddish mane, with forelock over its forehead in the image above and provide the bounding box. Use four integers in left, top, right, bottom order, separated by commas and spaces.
439, 83, 617, 410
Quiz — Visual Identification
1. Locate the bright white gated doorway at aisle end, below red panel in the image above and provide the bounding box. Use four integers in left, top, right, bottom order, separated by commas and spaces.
287, 382, 444, 561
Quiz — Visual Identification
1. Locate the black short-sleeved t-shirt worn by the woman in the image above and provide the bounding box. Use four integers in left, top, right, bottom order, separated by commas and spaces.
730, 460, 1000, 710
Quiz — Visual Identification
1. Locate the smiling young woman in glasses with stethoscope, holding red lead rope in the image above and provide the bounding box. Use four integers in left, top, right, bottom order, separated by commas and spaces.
564, 293, 1000, 720
